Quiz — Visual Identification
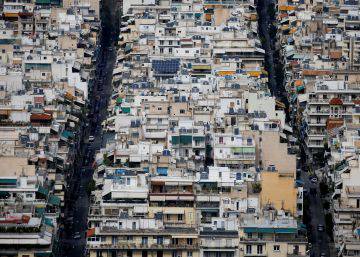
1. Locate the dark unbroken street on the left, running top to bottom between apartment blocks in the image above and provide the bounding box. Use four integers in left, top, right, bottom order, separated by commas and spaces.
56, 0, 119, 254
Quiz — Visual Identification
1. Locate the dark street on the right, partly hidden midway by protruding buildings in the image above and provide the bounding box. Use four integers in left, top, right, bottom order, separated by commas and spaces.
257, 0, 332, 257
